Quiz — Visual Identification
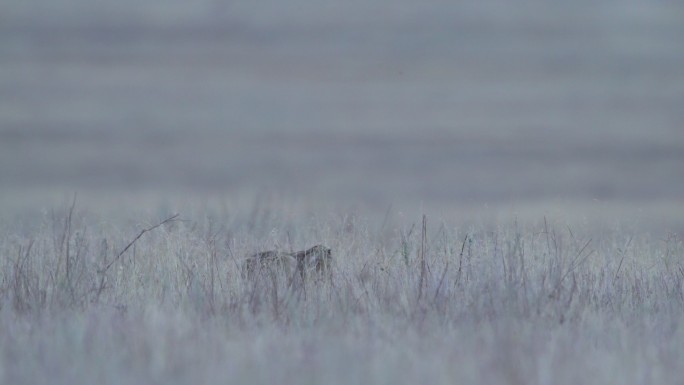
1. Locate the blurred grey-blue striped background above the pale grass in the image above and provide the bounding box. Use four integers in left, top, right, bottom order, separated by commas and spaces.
0, 0, 684, 229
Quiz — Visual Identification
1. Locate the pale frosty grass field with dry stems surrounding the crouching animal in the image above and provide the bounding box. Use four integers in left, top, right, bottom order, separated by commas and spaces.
0, 202, 684, 384
